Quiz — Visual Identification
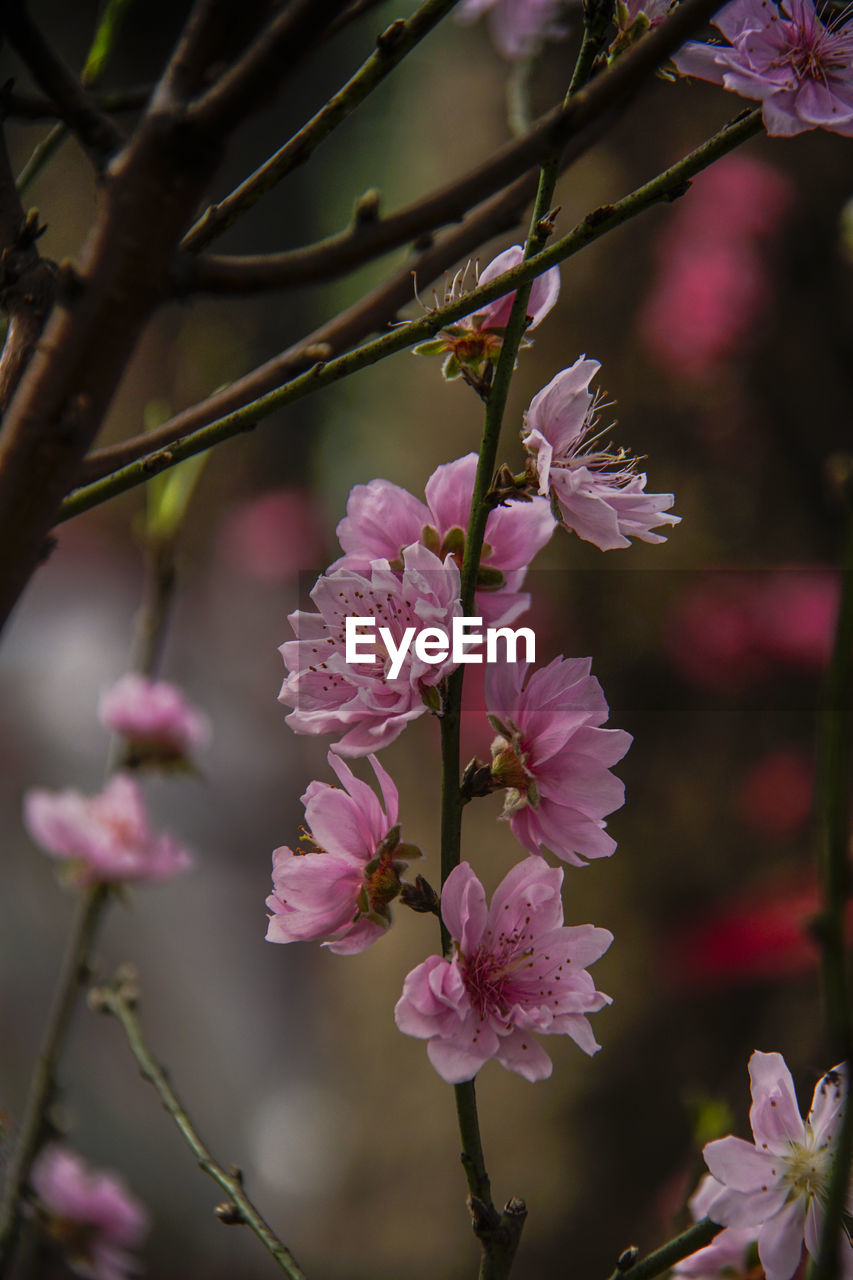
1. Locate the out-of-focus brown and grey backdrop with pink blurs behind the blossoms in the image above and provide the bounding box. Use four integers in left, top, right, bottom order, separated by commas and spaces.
0, 0, 853, 1280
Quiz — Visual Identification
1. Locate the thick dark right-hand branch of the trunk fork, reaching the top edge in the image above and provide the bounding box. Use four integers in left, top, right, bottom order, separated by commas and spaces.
188, 0, 356, 131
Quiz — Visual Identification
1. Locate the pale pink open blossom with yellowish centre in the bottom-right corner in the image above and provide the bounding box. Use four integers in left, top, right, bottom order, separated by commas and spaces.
704, 1050, 853, 1280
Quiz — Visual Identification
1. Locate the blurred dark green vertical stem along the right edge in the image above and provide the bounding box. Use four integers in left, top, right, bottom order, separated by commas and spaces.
812, 477, 853, 1280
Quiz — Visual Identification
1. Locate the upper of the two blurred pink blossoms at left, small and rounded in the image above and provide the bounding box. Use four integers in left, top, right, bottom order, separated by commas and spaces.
97, 673, 210, 763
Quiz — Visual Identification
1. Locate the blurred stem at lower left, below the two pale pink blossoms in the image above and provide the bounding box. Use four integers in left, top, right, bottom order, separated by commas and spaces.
0, 884, 110, 1276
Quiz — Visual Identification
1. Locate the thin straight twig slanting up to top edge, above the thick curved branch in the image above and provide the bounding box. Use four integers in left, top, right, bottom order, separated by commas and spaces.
181, 0, 466, 252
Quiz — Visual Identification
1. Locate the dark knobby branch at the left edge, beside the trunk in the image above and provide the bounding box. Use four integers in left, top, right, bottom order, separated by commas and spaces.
0, 131, 55, 417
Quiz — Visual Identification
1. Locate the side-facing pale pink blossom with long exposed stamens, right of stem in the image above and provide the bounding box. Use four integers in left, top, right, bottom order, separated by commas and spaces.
523, 356, 680, 552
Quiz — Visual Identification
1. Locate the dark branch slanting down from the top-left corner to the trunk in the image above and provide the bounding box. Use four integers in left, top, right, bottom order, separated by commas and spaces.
0, 0, 123, 169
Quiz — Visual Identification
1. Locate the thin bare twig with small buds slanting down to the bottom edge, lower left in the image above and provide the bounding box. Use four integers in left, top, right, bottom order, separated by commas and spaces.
92, 987, 306, 1280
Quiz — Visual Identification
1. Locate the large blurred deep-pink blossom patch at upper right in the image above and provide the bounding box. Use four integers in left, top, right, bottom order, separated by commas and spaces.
637, 156, 793, 381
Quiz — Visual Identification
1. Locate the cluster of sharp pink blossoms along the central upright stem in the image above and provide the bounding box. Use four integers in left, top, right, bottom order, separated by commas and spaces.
266, 246, 679, 1083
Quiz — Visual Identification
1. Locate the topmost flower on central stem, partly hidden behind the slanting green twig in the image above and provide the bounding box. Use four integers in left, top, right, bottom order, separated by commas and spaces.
412, 244, 560, 392
